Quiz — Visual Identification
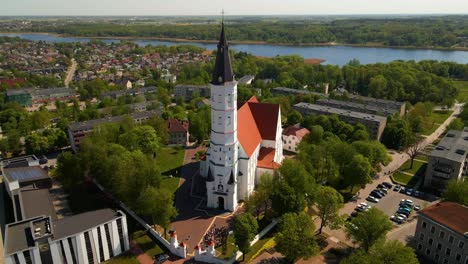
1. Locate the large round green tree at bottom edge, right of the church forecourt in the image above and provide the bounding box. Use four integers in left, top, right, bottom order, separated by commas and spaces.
275, 212, 319, 263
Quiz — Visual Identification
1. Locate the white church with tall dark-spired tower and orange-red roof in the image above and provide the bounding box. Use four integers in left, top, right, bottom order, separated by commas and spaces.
200, 23, 283, 211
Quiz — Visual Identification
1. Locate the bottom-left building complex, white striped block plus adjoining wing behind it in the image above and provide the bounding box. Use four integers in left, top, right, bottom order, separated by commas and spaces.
2, 166, 129, 264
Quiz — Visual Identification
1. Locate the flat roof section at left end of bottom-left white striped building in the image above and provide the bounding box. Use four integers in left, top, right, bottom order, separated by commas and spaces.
5, 217, 42, 255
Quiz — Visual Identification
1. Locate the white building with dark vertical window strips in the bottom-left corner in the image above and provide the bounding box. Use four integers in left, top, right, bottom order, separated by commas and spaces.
5, 209, 129, 264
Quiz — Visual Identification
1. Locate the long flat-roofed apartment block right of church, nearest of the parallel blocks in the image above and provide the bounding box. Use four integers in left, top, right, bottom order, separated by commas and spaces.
294, 103, 387, 140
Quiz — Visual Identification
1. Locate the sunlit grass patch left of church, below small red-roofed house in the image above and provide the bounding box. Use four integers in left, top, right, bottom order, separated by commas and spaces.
156, 147, 185, 176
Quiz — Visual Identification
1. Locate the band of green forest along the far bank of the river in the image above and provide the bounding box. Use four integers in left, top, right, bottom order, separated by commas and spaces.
24, 16, 468, 48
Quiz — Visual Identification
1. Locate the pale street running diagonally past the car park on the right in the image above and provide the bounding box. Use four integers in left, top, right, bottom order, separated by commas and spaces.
315, 104, 463, 246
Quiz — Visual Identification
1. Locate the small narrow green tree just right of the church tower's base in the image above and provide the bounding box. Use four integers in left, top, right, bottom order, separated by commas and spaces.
234, 213, 258, 261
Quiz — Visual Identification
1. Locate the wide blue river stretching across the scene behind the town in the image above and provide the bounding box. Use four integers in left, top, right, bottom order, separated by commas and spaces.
0, 34, 468, 66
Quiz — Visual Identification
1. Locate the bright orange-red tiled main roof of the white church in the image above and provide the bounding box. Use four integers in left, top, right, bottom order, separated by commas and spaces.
237, 96, 280, 157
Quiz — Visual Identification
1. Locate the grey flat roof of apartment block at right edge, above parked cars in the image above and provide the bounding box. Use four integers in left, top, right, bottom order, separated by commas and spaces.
429, 127, 468, 162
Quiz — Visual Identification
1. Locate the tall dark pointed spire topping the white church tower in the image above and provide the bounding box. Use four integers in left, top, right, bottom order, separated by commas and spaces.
211, 15, 234, 85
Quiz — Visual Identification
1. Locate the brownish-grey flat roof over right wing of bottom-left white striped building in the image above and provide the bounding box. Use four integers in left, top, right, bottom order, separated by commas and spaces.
52, 208, 121, 240
